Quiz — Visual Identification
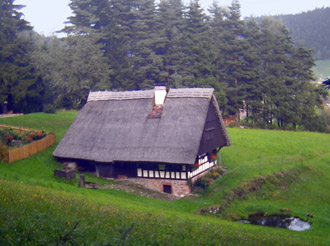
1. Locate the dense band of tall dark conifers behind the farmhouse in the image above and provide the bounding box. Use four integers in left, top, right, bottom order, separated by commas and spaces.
0, 0, 327, 131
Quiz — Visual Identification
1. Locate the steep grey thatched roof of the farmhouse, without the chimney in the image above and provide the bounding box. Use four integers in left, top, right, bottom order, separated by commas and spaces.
53, 88, 230, 164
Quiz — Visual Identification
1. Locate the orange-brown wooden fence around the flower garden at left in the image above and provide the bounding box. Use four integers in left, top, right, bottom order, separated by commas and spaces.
0, 125, 56, 162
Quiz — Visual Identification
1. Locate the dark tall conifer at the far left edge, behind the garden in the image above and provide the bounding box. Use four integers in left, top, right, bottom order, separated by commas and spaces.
0, 0, 44, 113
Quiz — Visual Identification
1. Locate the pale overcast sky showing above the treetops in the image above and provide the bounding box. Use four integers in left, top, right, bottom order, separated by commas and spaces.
15, 0, 330, 35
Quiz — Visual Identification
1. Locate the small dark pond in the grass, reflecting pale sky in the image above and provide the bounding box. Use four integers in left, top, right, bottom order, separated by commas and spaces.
238, 213, 311, 231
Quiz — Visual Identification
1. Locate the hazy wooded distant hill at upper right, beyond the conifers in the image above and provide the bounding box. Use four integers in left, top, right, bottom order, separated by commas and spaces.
274, 7, 330, 60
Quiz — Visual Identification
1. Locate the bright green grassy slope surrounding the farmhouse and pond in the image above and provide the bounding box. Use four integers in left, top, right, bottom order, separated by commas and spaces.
0, 111, 330, 245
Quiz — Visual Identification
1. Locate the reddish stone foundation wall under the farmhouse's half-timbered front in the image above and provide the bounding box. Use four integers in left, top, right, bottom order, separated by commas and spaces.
129, 178, 191, 197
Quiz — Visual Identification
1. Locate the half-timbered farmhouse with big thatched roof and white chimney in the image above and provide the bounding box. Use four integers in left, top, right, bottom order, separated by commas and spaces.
53, 87, 230, 196
